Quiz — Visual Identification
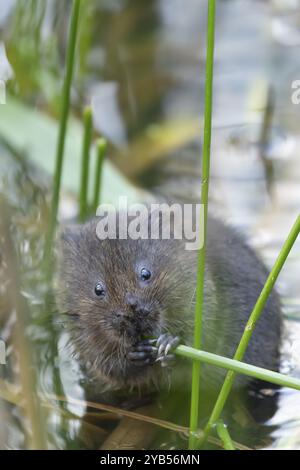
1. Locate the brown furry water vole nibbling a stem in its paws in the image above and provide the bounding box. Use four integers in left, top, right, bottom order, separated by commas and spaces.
58, 210, 281, 388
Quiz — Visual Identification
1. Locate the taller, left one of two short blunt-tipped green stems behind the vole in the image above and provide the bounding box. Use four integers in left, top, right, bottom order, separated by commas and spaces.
79, 106, 93, 221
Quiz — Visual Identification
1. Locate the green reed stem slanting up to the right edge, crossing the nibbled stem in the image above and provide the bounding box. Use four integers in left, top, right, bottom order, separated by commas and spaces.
200, 215, 300, 445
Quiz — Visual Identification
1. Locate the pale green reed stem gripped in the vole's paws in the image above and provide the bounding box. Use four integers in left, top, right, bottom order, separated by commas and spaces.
174, 345, 300, 391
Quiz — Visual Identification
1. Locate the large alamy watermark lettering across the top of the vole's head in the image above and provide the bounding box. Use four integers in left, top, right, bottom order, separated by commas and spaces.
96, 196, 204, 250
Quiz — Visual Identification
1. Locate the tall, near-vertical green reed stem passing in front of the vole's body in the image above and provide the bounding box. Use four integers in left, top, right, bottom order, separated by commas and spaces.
189, 0, 215, 449
